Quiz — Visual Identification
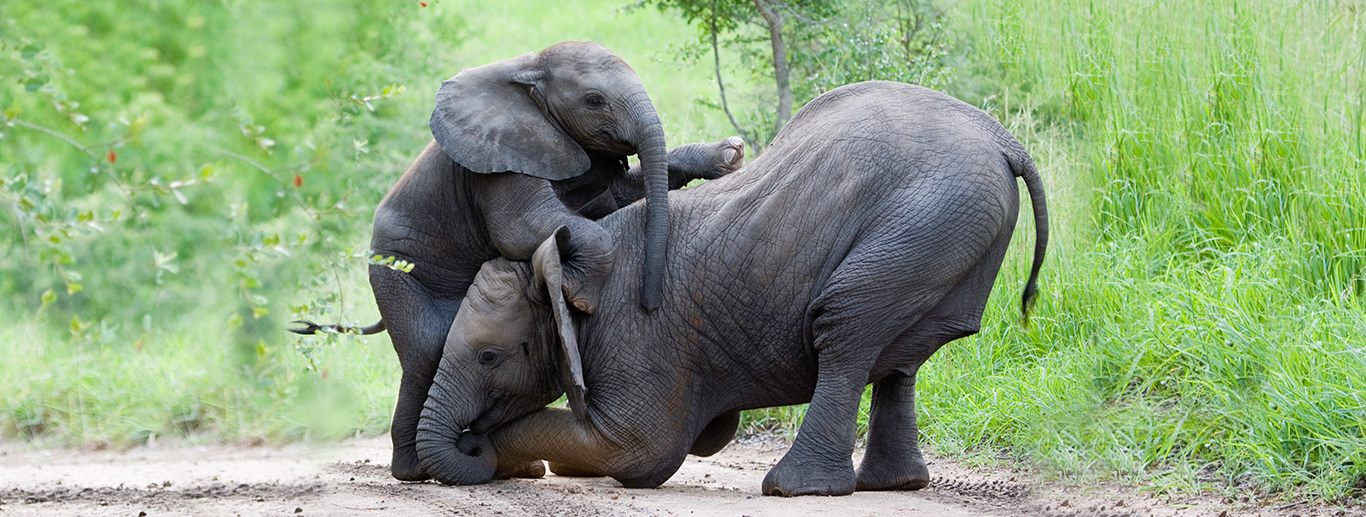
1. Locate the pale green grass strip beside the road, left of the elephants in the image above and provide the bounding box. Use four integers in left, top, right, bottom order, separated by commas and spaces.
0, 318, 399, 446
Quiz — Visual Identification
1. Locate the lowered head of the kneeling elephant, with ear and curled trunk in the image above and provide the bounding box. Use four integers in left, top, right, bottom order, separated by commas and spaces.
417, 227, 586, 484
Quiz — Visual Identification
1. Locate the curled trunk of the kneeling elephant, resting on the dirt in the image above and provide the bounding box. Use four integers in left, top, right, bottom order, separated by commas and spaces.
417, 358, 497, 484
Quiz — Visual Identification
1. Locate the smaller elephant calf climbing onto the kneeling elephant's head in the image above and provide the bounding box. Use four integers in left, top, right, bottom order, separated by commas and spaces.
281, 42, 744, 480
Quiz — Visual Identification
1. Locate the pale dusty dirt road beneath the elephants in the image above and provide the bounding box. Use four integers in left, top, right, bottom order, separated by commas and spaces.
0, 436, 1366, 517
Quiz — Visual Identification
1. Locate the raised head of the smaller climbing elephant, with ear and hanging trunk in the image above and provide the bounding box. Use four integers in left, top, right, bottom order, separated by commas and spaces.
432, 42, 669, 310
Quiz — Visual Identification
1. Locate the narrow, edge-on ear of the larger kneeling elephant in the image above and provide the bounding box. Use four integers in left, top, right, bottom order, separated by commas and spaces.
531, 226, 589, 420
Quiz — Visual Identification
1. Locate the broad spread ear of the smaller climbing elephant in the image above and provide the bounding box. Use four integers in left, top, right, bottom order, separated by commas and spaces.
432, 53, 590, 181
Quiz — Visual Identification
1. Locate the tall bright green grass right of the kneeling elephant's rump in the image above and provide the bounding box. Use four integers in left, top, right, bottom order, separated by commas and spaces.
919, 0, 1366, 498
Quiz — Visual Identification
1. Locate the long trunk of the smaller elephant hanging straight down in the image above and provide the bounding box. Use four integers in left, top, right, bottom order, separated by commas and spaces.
631, 92, 669, 310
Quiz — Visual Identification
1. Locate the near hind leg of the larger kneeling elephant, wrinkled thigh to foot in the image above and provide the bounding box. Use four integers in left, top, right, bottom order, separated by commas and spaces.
764, 213, 996, 495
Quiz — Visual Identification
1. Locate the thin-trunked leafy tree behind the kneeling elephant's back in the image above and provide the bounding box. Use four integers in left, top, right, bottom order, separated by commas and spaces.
635, 0, 949, 149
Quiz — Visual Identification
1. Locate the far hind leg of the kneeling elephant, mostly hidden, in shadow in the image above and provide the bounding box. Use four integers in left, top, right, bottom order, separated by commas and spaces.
856, 373, 930, 490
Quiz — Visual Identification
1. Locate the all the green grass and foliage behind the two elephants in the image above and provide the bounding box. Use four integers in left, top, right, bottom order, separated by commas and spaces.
0, 0, 1366, 499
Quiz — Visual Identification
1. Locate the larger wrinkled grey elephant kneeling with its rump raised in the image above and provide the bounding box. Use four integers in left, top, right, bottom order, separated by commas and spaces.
418, 82, 1048, 495
